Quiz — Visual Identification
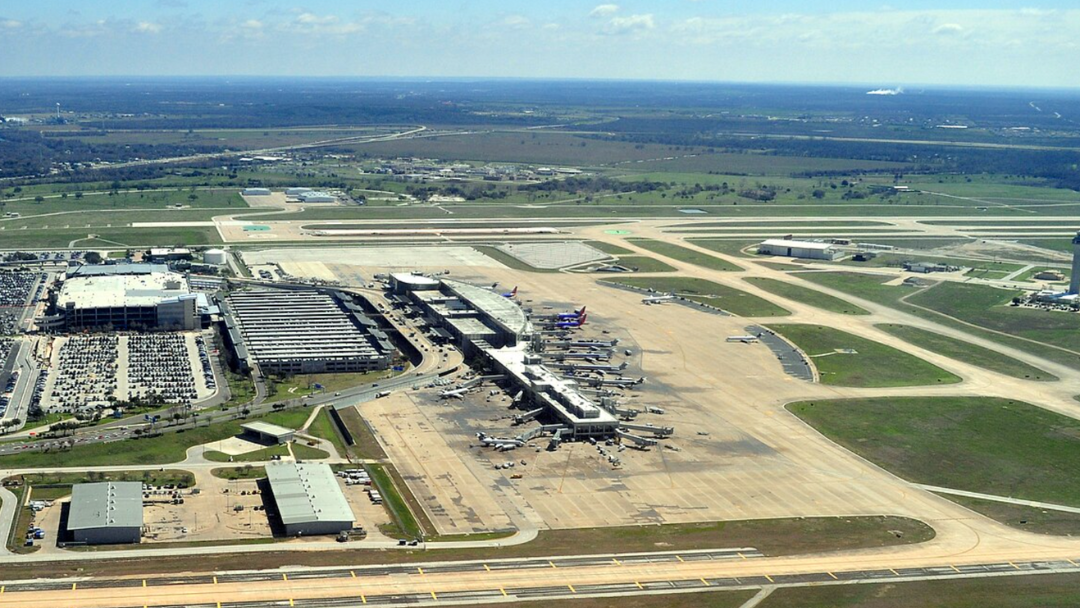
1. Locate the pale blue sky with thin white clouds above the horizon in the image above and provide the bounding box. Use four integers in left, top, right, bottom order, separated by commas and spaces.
0, 0, 1080, 87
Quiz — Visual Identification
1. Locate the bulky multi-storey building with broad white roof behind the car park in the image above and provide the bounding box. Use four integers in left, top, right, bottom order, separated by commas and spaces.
40, 264, 206, 330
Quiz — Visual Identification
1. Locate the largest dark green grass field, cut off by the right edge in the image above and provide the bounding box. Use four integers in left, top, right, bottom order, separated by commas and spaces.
787, 397, 1080, 506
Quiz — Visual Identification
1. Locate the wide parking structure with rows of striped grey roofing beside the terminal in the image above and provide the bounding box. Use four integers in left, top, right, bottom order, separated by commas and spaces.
221, 289, 393, 374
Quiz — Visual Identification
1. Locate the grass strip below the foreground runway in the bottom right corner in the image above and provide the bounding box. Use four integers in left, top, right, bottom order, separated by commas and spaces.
764, 575, 1080, 608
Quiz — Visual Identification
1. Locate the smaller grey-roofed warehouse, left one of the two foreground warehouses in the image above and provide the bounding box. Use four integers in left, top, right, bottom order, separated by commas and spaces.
67, 482, 143, 544
